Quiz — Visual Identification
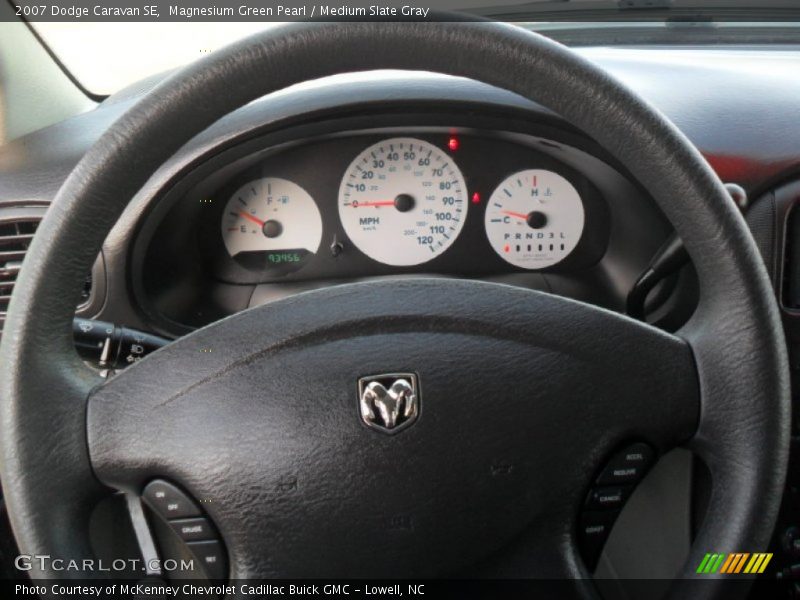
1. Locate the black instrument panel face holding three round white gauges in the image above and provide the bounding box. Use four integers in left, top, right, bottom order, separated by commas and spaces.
202, 133, 607, 283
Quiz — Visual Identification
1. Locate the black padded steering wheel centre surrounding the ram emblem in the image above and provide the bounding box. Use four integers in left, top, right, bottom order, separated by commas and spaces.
88, 279, 699, 577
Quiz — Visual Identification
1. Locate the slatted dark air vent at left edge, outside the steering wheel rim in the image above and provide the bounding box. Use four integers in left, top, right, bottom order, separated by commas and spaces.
0, 209, 43, 333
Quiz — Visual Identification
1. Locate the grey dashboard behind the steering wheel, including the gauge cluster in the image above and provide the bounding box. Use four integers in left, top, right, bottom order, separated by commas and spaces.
6, 48, 800, 338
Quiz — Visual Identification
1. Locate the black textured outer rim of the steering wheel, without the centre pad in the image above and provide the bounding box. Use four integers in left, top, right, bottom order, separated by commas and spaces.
0, 18, 790, 597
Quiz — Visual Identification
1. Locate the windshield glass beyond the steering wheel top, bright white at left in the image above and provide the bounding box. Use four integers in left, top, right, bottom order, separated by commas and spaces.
27, 0, 800, 96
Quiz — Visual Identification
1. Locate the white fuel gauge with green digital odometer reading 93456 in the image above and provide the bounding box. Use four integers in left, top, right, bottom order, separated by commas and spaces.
222, 177, 322, 273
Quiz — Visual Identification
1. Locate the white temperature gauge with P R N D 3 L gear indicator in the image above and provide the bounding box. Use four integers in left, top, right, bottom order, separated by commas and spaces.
485, 169, 584, 269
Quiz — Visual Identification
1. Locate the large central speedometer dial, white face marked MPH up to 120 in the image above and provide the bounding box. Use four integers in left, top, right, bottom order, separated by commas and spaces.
339, 138, 467, 266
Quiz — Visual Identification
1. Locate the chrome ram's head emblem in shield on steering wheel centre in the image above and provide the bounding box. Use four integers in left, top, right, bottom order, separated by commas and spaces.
358, 373, 419, 433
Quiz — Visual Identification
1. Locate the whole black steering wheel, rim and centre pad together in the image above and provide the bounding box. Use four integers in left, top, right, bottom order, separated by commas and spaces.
0, 22, 790, 598
